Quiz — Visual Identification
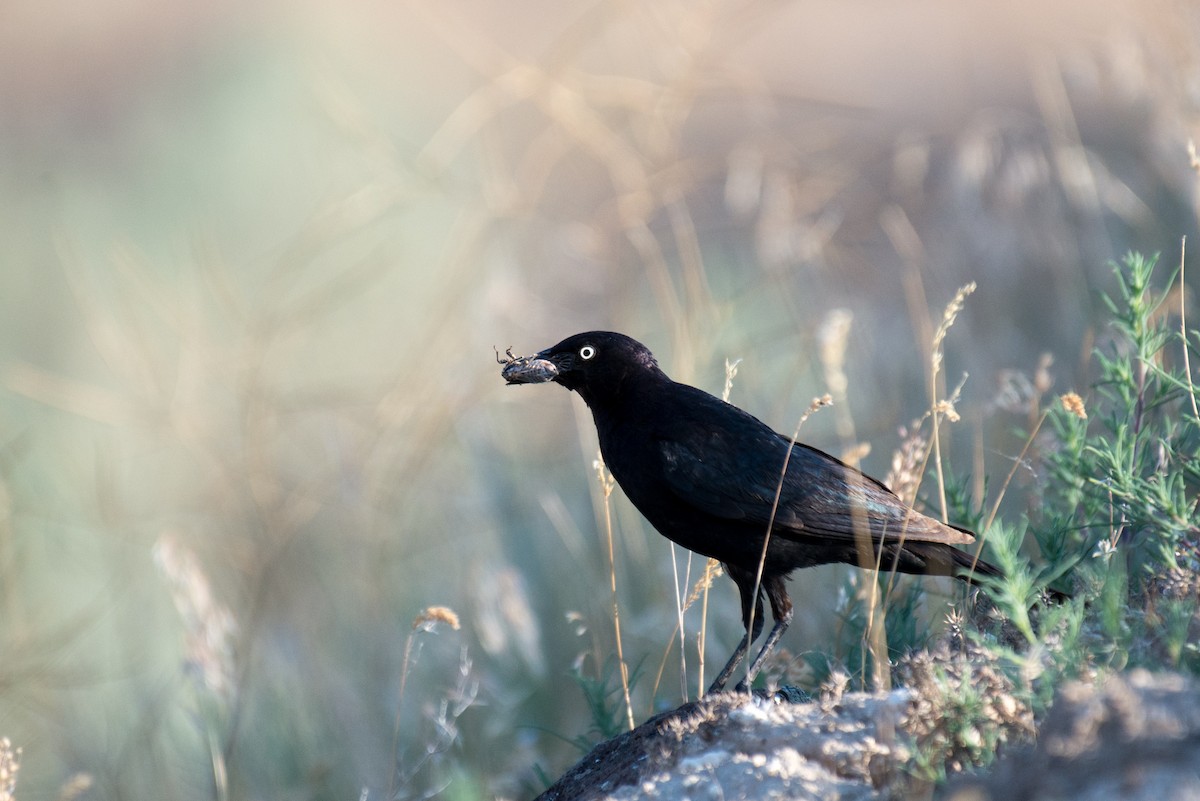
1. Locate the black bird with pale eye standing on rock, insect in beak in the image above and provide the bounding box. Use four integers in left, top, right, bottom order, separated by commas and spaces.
500, 331, 1001, 692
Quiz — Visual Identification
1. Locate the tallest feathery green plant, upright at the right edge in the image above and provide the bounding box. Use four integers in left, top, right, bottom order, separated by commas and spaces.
1044, 254, 1200, 575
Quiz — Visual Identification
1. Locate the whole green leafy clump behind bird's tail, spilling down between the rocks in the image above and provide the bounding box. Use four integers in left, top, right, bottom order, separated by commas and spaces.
907, 254, 1200, 778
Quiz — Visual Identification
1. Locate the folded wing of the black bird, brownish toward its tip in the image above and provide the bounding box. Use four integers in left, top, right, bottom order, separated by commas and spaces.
659, 431, 974, 544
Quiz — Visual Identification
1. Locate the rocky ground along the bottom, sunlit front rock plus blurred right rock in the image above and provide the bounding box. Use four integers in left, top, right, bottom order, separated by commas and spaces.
540, 670, 1200, 801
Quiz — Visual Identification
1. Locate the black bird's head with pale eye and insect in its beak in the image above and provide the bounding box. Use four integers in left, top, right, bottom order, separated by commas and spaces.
500, 331, 665, 405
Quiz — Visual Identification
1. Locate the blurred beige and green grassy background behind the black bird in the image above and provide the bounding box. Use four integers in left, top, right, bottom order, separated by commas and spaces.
0, 0, 1200, 799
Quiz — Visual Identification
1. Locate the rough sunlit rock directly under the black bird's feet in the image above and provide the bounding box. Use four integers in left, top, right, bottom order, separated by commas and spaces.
539, 691, 911, 801
